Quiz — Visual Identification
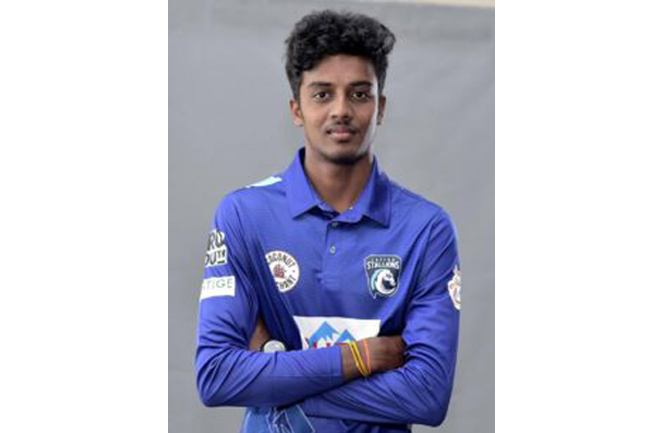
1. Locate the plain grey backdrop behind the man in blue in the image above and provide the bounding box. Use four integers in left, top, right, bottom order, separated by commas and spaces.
170, 0, 494, 433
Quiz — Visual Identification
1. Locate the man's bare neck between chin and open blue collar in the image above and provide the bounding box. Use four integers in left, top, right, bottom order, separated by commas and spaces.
304, 149, 372, 213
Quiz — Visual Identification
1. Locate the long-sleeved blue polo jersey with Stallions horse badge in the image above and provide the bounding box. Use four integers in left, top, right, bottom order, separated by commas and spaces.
195, 148, 460, 433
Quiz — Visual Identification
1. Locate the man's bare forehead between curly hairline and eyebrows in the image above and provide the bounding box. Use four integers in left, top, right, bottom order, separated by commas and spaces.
302, 54, 377, 86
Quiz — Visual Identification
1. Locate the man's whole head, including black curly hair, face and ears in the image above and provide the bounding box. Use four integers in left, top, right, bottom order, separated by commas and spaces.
286, 11, 395, 164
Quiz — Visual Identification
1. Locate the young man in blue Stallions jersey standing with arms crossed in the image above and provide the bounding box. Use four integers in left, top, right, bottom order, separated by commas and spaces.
196, 11, 460, 433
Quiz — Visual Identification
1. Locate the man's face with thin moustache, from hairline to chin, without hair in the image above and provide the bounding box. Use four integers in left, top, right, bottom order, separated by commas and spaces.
290, 54, 386, 164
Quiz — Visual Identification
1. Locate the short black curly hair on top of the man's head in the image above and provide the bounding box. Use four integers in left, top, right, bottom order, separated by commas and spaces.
285, 10, 395, 100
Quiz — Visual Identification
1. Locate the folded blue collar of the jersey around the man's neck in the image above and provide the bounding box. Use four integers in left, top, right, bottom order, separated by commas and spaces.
283, 147, 391, 226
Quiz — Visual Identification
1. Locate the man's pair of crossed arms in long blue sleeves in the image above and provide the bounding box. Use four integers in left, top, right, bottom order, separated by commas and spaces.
196, 196, 459, 426
